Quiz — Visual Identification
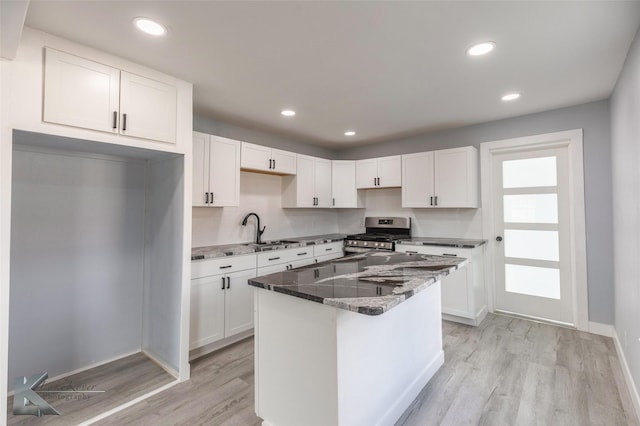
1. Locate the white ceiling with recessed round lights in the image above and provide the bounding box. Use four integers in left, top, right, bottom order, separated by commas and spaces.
26, 0, 640, 149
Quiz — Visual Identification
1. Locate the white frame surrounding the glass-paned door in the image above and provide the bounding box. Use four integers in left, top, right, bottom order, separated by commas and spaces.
480, 129, 589, 331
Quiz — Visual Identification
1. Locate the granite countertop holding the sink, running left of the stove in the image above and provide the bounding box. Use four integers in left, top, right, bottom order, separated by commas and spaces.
191, 234, 346, 260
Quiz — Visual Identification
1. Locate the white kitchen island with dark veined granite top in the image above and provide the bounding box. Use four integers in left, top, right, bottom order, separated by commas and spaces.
249, 251, 467, 426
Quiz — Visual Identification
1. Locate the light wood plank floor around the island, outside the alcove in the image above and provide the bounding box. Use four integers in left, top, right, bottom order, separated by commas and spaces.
10, 315, 640, 426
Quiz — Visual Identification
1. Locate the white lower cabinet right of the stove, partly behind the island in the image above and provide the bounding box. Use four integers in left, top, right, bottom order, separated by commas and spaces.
396, 244, 487, 326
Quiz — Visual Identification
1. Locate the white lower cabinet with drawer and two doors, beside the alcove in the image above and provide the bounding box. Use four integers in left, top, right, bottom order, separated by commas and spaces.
189, 254, 256, 350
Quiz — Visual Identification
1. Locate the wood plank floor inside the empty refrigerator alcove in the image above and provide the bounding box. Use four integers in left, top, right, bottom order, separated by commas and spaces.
7, 353, 175, 426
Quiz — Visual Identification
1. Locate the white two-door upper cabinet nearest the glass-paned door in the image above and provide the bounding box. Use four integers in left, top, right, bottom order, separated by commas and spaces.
402, 146, 479, 208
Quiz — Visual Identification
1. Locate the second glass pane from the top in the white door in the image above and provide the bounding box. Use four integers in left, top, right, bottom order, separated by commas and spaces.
504, 194, 558, 223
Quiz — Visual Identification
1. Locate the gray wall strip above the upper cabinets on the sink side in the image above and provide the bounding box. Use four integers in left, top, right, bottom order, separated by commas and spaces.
193, 115, 336, 159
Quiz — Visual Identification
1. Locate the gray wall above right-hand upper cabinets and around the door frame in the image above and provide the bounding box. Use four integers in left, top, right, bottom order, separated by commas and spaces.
338, 100, 614, 324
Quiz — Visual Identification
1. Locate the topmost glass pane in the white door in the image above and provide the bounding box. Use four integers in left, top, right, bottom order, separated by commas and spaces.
502, 157, 558, 188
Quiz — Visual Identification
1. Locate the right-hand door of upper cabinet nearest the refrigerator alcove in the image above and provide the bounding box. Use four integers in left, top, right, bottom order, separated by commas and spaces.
209, 136, 240, 207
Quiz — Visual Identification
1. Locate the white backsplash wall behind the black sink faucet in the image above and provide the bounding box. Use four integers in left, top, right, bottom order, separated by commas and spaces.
191, 172, 338, 247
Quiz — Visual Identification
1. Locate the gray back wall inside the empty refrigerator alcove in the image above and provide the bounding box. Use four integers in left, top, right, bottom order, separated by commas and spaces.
8, 141, 145, 389
